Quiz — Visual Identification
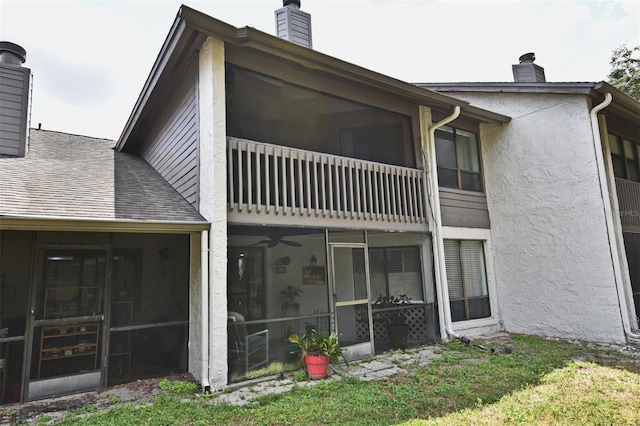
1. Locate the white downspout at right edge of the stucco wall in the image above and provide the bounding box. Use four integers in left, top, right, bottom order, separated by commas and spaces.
590, 92, 640, 339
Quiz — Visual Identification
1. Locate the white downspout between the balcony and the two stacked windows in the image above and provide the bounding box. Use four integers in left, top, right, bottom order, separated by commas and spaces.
423, 106, 470, 344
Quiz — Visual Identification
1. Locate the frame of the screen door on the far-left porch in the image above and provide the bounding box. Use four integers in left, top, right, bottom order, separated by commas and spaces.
21, 243, 113, 401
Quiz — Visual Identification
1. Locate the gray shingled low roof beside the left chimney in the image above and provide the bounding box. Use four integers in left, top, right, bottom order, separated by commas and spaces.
0, 129, 206, 223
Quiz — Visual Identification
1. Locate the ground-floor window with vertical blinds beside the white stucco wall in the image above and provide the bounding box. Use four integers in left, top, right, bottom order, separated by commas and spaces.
444, 240, 491, 321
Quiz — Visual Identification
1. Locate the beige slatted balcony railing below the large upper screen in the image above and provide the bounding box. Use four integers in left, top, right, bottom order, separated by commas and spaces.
227, 137, 427, 228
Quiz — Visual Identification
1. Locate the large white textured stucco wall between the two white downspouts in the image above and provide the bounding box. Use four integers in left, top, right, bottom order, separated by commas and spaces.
456, 94, 625, 342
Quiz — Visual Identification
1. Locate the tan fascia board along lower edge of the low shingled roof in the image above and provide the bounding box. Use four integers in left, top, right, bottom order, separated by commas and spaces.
0, 216, 210, 234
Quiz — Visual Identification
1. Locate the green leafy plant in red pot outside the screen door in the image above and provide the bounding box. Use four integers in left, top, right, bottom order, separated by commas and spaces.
298, 330, 349, 380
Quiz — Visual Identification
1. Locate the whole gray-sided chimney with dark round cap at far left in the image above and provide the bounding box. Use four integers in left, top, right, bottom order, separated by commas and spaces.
0, 41, 31, 157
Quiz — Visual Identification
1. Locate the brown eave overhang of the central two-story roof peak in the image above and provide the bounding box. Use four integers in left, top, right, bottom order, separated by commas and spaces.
116, 5, 510, 150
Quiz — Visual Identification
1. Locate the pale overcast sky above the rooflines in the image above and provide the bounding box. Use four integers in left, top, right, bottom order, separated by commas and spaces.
0, 0, 640, 140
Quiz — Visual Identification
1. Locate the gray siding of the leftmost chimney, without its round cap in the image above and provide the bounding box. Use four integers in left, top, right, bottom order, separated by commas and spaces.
0, 64, 31, 157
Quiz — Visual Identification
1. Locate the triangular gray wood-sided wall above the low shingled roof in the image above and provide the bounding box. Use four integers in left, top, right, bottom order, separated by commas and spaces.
140, 60, 198, 206
